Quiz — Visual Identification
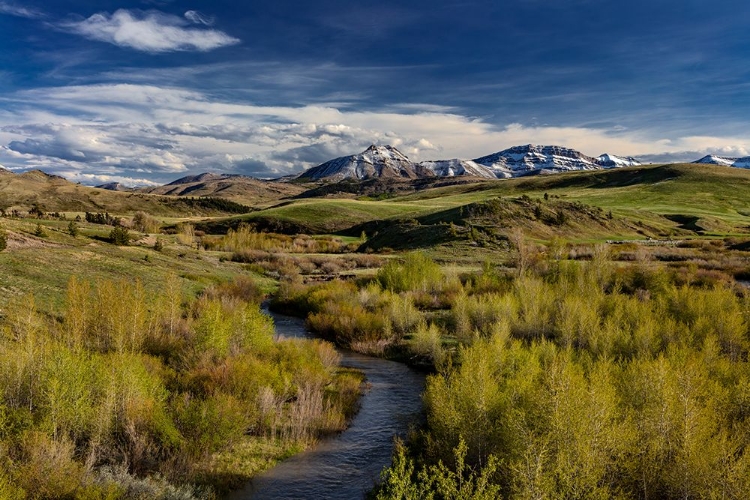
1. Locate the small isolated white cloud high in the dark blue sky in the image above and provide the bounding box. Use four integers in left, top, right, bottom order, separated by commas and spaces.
60, 9, 240, 53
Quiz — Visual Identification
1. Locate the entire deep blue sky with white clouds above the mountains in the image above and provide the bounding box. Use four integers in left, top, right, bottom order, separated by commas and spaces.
0, 0, 750, 185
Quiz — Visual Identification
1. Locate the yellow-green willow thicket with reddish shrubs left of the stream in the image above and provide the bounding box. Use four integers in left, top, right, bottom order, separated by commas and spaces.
0, 279, 359, 498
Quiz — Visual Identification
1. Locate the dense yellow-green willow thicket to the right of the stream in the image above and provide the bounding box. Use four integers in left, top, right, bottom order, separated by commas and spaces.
390, 259, 750, 498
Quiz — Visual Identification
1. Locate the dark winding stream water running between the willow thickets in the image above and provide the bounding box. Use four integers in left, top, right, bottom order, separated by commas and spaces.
229, 306, 425, 500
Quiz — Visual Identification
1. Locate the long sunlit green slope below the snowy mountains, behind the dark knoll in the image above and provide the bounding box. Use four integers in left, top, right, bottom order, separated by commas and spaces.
238, 164, 750, 234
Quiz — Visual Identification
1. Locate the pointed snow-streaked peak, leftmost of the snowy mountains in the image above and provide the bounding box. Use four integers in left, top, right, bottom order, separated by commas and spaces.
298, 145, 419, 181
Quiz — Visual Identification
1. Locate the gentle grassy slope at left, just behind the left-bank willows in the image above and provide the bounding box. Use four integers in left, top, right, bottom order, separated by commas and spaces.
0, 219, 274, 312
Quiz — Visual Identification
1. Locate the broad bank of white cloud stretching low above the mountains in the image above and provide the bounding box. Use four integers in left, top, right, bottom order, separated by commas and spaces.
0, 84, 750, 184
